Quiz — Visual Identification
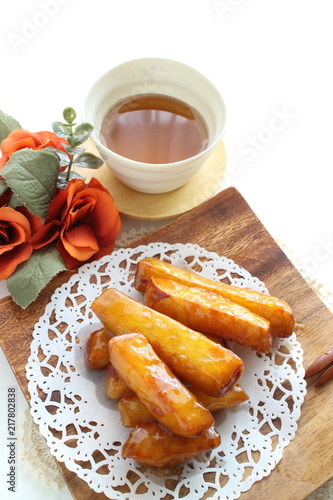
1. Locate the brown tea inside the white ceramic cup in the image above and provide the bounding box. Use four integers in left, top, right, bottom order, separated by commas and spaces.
100, 94, 208, 164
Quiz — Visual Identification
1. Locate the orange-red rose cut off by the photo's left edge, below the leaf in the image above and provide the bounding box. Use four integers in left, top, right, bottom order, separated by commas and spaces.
0, 206, 43, 280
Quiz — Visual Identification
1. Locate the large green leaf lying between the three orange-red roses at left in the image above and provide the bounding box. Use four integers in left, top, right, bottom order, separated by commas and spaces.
1, 148, 60, 218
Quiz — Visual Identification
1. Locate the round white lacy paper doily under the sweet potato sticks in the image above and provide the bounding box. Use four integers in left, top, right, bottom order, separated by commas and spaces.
26, 243, 306, 500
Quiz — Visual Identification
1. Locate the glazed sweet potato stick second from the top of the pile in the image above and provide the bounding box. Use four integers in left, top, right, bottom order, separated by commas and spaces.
145, 277, 272, 354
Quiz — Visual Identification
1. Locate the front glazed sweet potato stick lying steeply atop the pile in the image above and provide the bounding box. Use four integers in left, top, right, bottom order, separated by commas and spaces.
109, 333, 214, 437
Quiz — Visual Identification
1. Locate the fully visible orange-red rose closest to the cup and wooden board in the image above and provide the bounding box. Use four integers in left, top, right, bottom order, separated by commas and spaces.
33, 178, 121, 269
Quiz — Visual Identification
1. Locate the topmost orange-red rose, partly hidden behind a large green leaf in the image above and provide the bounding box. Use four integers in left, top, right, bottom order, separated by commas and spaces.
0, 129, 68, 171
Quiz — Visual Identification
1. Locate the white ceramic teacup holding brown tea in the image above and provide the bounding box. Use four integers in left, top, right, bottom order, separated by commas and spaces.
83, 58, 226, 193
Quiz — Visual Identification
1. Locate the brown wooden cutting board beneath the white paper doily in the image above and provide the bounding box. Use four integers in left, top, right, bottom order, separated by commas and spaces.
0, 188, 333, 500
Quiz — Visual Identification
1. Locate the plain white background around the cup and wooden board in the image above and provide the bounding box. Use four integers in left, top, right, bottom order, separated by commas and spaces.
0, 0, 333, 500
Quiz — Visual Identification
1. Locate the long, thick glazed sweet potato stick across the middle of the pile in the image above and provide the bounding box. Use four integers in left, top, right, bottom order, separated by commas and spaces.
92, 288, 244, 397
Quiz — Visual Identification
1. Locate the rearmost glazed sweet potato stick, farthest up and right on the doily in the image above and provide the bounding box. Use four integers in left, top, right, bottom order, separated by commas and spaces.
134, 257, 294, 337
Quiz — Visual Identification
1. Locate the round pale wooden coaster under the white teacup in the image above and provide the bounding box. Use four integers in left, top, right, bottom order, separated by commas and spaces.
76, 140, 227, 220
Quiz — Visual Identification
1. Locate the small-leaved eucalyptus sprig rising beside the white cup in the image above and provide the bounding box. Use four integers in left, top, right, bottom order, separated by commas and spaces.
52, 107, 103, 189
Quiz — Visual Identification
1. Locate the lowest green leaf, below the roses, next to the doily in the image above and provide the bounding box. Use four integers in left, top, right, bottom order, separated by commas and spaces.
6, 245, 66, 309
